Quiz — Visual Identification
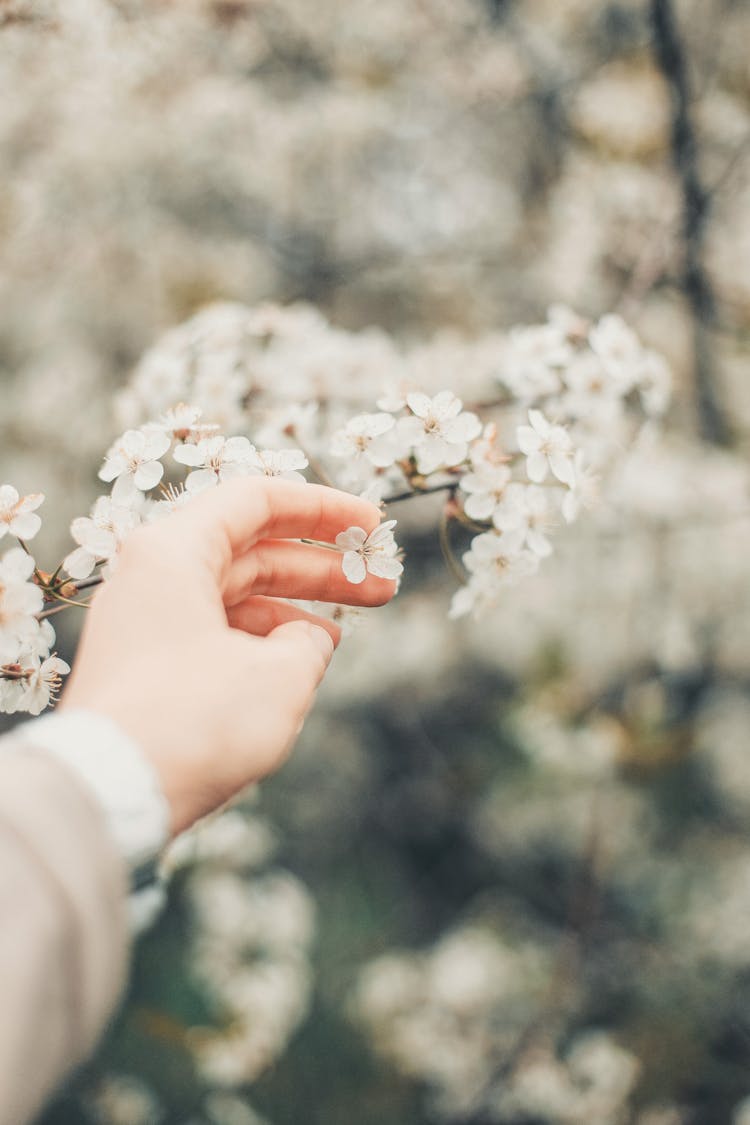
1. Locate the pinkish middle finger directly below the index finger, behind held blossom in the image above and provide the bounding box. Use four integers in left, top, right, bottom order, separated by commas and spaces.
224, 539, 396, 606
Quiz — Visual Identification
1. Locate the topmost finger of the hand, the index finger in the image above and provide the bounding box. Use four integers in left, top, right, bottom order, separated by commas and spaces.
163, 477, 380, 577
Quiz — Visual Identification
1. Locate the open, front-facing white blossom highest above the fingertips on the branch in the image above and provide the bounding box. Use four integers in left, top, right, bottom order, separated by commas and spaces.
397, 390, 481, 474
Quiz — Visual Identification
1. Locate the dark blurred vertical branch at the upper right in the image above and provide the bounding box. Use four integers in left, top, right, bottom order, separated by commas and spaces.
650, 0, 731, 446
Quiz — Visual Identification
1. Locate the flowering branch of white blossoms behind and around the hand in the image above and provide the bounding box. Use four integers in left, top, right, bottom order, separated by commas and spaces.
0, 305, 669, 713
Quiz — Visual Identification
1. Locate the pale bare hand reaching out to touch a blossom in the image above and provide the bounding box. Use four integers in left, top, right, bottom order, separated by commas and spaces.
60, 477, 396, 834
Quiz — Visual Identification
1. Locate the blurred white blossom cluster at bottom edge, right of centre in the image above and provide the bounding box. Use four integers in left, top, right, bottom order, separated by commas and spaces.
351, 925, 639, 1125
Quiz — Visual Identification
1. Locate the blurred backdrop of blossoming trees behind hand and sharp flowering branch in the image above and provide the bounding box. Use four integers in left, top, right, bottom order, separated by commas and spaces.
0, 0, 750, 1125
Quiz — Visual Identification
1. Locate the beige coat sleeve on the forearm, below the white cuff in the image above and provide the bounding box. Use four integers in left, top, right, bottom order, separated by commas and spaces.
0, 725, 128, 1125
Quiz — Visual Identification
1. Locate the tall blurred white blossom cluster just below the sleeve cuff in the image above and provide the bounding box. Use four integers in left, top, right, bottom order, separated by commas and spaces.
168, 809, 315, 1088
